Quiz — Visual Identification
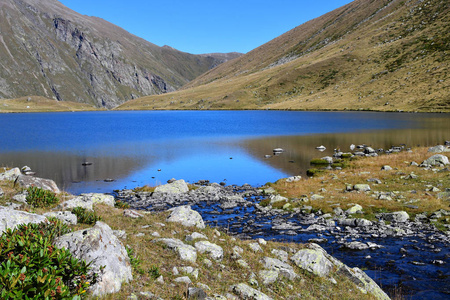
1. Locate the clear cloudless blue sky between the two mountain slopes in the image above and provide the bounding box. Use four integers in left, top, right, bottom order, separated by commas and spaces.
60, 0, 352, 54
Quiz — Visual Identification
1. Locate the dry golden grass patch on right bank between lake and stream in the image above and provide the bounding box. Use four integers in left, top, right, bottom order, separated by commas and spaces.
271, 148, 450, 218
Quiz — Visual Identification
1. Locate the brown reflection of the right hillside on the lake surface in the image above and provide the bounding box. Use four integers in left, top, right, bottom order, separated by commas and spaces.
240, 126, 450, 176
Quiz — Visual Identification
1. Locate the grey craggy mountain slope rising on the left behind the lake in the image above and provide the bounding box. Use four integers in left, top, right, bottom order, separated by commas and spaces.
0, 0, 240, 108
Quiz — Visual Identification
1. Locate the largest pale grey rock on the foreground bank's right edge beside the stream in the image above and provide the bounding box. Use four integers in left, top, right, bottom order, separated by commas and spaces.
291, 249, 333, 277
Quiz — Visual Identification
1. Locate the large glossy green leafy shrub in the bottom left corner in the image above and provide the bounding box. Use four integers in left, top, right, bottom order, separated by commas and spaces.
0, 220, 96, 299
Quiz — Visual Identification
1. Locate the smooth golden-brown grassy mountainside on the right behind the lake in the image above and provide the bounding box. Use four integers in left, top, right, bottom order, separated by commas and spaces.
119, 0, 450, 111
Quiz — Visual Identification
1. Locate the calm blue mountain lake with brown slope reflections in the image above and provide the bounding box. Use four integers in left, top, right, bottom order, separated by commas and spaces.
0, 111, 450, 194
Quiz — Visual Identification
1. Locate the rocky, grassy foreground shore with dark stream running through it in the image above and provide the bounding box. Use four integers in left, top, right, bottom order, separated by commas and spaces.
0, 145, 450, 299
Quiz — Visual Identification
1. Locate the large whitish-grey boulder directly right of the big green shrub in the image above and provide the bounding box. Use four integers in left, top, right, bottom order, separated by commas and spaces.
54, 221, 133, 296
